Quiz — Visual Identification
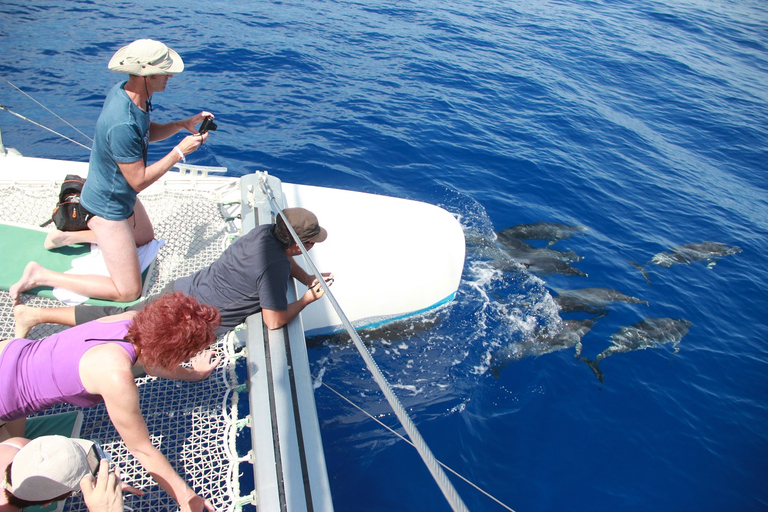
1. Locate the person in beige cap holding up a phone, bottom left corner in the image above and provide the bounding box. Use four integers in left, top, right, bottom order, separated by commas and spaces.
0, 435, 144, 512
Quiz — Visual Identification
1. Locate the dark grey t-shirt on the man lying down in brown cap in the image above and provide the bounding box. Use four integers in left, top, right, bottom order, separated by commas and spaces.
173, 224, 291, 335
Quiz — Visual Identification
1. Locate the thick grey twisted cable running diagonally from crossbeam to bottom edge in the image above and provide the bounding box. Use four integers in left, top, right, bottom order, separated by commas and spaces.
258, 172, 469, 512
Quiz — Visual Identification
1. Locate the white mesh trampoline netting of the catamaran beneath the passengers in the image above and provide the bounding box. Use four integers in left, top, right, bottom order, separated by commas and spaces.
0, 179, 252, 512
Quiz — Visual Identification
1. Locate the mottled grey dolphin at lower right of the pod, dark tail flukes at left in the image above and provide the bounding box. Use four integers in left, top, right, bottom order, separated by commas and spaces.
580, 318, 693, 382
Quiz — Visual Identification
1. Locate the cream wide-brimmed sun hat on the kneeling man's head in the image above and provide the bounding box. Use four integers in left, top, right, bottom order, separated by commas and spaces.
108, 39, 184, 76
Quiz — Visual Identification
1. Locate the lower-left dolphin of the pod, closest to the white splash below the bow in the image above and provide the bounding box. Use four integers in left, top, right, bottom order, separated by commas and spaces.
491, 320, 596, 377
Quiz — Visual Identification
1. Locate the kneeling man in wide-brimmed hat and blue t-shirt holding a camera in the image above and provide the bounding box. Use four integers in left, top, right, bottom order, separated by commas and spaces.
10, 39, 213, 304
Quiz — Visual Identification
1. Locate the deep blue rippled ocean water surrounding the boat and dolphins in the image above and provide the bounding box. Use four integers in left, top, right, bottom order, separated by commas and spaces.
0, 0, 768, 512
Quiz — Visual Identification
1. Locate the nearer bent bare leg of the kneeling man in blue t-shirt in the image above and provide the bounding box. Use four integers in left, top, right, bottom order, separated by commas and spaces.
9, 217, 141, 304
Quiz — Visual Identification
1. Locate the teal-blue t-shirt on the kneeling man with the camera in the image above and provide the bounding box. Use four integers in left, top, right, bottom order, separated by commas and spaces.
80, 82, 149, 220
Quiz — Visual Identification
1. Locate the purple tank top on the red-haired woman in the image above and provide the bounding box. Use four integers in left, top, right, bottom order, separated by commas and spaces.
0, 320, 136, 421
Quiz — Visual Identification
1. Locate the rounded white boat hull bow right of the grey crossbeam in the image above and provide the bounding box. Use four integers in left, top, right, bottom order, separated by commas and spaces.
283, 183, 465, 335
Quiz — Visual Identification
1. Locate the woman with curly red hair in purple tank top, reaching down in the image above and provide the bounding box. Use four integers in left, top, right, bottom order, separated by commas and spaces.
0, 292, 221, 512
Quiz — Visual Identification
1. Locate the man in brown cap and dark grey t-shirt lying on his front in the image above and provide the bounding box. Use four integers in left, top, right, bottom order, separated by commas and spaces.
13, 208, 333, 338
